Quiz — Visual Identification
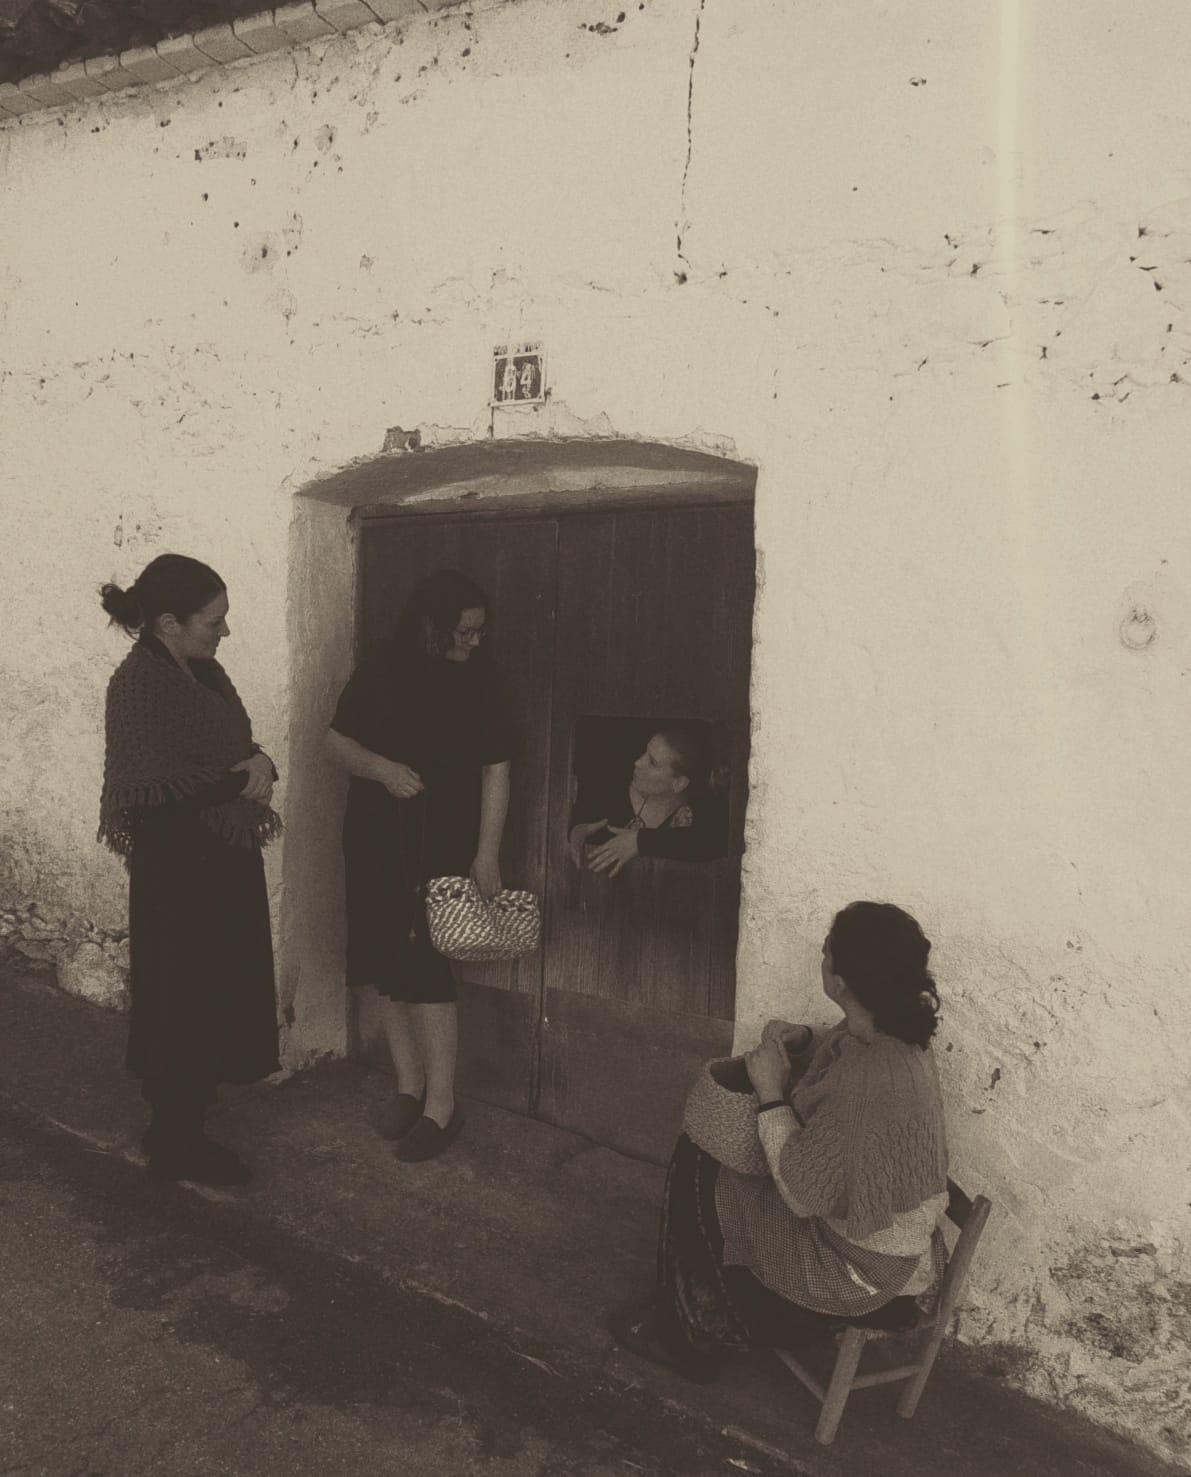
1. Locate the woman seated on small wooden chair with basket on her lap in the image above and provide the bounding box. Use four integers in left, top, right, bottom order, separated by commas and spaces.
612, 902, 947, 1380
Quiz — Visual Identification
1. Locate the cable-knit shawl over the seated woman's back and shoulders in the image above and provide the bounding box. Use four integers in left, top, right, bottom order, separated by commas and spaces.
782, 1024, 947, 1241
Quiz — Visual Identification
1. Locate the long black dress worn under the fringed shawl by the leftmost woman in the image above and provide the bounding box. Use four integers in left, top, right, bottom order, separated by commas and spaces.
127, 638, 278, 1089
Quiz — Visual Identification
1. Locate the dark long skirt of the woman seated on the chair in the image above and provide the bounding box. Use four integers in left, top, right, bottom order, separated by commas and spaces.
655, 1134, 916, 1368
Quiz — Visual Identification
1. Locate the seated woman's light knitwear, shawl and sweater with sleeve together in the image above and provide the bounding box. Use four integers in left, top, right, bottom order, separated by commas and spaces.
715, 1024, 947, 1316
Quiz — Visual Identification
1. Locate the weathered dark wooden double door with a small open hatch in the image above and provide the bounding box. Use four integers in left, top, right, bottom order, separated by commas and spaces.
356, 502, 754, 1159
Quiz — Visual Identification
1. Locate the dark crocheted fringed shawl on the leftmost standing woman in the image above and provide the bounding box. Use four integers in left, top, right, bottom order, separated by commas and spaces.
99, 641, 281, 860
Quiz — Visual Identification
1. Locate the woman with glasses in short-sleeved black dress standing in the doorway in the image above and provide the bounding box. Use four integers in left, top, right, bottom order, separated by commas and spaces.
327, 570, 514, 1161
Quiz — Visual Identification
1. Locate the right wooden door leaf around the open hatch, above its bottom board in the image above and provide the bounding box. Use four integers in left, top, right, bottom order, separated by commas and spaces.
547, 508, 754, 1019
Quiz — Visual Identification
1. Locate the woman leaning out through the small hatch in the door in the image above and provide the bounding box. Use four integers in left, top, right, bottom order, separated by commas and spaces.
567, 725, 726, 877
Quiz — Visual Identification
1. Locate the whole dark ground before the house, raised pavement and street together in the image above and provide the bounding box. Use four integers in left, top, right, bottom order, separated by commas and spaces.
0, 959, 1163, 1477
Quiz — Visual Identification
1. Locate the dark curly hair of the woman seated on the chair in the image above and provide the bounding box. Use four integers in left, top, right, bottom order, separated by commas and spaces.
827, 902, 938, 1049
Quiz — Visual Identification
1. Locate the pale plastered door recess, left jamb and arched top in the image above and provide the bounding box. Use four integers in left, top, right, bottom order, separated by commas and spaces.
276, 436, 758, 1116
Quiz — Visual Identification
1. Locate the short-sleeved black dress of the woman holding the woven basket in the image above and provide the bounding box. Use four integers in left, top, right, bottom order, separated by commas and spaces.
331, 644, 514, 1004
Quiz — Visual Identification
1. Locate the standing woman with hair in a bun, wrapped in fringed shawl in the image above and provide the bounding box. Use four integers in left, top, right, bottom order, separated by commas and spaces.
99, 554, 281, 1185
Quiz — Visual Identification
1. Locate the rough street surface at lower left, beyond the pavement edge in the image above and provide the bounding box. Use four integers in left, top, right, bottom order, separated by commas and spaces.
0, 1109, 786, 1477
